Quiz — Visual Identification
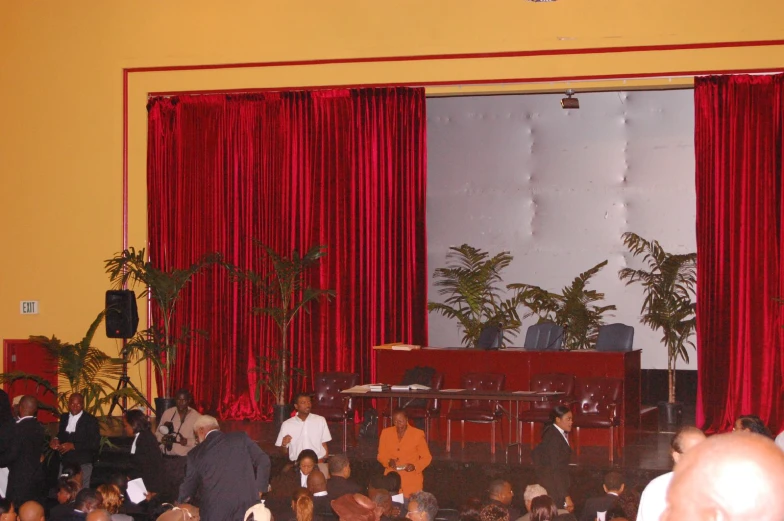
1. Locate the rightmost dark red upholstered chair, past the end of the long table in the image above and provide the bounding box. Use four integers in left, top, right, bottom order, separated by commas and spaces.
572, 377, 623, 461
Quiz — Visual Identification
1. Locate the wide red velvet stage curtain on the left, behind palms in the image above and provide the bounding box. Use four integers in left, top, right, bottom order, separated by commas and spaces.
148, 88, 427, 419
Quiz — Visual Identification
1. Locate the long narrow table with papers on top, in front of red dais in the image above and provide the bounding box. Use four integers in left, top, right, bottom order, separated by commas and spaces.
341, 386, 564, 457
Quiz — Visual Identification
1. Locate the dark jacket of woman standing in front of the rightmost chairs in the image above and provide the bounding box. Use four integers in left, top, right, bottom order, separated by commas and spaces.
531, 425, 572, 508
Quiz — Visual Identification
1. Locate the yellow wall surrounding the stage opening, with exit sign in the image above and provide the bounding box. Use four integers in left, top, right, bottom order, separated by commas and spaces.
0, 0, 784, 394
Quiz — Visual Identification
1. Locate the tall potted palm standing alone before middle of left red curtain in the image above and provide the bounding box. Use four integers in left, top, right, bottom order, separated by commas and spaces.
240, 240, 335, 424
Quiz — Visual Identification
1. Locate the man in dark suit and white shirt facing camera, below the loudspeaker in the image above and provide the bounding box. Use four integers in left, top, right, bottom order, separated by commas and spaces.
49, 393, 101, 488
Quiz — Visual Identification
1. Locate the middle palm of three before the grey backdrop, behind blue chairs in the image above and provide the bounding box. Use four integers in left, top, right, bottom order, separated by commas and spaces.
510, 260, 616, 350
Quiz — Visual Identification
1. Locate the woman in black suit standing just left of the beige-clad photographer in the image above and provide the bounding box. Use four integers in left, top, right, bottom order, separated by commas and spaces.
123, 409, 171, 501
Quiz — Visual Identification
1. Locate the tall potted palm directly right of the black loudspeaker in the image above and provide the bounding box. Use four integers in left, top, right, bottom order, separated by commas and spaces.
105, 247, 220, 412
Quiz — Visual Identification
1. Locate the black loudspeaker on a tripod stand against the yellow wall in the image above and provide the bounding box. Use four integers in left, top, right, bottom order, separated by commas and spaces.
105, 289, 153, 416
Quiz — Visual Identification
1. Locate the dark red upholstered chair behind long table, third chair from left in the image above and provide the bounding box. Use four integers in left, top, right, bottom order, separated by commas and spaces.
446, 373, 506, 454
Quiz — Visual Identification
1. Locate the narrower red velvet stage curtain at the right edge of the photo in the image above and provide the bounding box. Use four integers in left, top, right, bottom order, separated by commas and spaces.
694, 75, 784, 431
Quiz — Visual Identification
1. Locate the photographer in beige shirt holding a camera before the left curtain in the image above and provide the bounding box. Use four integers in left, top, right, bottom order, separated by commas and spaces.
155, 389, 201, 489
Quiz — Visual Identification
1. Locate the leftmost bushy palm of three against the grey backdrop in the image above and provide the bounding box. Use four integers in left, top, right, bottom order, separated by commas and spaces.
427, 244, 522, 347
